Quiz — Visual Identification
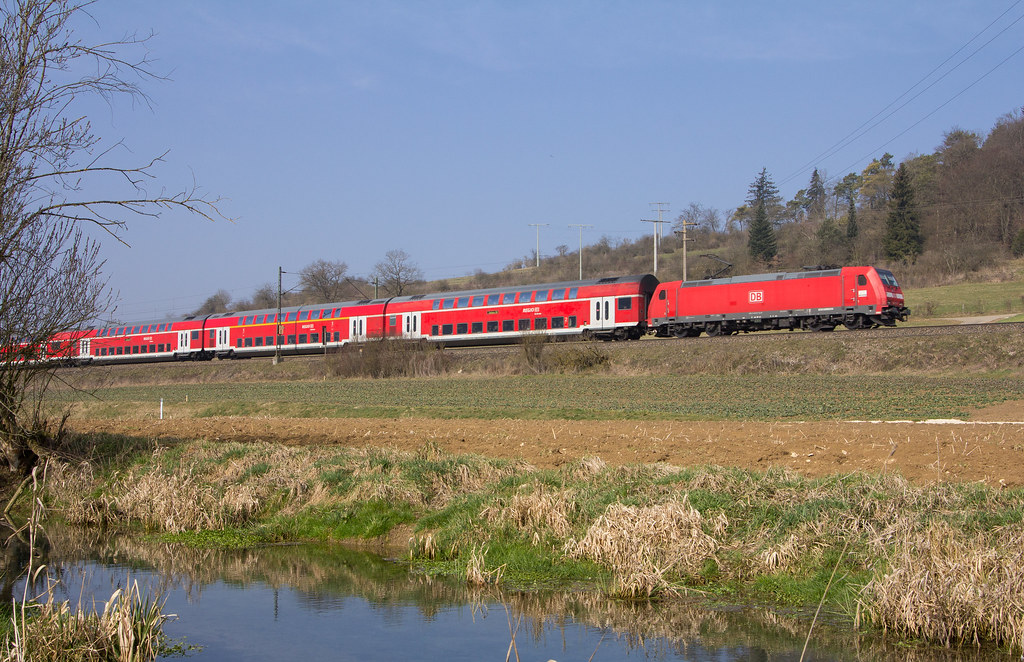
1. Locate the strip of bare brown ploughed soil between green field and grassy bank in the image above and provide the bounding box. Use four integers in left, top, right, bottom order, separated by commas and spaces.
71, 402, 1024, 488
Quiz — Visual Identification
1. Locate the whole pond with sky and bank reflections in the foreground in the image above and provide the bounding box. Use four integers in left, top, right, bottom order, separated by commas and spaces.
4, 529, 1014, 662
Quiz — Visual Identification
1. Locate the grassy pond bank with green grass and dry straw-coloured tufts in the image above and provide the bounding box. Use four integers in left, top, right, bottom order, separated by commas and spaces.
41, 437, 1024, 650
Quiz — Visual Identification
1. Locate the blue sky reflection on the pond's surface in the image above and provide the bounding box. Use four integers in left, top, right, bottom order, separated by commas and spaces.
17, 562, 790, 662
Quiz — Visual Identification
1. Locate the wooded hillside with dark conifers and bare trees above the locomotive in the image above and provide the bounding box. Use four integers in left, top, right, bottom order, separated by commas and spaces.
676, 111, 1024, 285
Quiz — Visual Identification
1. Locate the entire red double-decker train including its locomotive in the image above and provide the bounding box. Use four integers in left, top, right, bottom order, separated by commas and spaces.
22, 266, 909, 364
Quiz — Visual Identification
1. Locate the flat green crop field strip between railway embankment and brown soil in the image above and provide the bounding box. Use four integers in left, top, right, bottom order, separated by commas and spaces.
58, 374, 1024, 420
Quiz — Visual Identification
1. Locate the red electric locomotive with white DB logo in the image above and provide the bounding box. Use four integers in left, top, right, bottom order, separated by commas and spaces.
647, 266, 910, 337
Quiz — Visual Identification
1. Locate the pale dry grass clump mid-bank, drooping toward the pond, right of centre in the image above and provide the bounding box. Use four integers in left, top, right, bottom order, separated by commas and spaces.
565, 495, 719, 597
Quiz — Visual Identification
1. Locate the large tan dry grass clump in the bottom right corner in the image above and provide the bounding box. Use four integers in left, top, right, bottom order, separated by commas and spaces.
862, 523, 1024, 649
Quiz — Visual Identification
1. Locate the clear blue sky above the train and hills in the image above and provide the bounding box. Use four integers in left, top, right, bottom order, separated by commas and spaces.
74, 0, 1024, 321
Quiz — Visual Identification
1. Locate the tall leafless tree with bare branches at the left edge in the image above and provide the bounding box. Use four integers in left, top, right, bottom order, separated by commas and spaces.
0, 0, 223, 471
